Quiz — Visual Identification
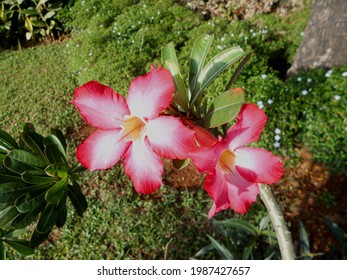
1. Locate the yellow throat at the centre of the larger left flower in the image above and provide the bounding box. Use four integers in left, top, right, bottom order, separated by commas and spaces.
121, 116, 146, 141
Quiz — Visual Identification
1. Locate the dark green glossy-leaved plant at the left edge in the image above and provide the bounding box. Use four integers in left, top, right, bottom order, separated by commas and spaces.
0, 124, 87, 254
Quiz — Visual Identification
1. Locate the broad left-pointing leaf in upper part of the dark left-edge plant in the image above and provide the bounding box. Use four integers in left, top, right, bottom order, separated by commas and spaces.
4, 150, 46, 174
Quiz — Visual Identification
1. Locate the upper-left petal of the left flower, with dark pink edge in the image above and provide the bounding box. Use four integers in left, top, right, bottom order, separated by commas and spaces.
70, 81, 129, 129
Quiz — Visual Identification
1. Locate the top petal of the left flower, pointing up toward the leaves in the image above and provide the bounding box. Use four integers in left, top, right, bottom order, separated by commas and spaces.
127, 67, 175, 119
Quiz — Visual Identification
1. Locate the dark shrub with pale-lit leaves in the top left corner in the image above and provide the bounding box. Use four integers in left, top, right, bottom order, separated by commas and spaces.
0, 0, 65, 47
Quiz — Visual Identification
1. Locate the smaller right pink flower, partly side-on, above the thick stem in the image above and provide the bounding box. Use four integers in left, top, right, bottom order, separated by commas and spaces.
186, 104, 283, 218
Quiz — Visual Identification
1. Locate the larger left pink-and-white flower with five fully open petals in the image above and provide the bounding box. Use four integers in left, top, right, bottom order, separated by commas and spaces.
71, 66, 194, 193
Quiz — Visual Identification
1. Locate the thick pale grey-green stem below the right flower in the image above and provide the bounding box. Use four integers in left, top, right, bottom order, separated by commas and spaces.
259, 184, 295, 260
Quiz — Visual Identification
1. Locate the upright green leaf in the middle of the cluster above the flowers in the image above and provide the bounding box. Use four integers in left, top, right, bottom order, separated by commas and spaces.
189, 35, 213, 93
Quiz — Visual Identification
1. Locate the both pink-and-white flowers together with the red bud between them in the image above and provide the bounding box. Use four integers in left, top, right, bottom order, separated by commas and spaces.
71, 66, 283, 218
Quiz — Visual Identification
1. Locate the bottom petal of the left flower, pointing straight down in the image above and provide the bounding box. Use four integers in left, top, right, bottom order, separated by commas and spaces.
124, 139, 163, 194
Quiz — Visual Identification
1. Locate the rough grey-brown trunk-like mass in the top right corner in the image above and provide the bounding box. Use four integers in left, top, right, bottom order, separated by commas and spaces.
287, 0, 347, 76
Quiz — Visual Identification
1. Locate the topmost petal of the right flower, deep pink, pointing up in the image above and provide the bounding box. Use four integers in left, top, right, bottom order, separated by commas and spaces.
225, 103, 266, 150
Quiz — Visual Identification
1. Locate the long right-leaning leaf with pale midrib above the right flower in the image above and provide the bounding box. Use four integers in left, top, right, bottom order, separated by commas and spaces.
191, 47, 244, 104
